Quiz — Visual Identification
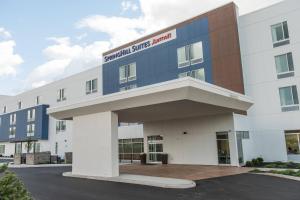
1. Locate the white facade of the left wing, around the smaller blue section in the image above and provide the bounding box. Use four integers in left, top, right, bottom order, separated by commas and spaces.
0, 67, 113, 158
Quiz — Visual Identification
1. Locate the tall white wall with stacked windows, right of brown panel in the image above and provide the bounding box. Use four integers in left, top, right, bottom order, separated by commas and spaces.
239, 0, 300, 161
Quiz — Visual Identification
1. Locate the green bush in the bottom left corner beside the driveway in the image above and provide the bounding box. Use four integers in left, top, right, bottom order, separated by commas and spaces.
0, 165, 32, 200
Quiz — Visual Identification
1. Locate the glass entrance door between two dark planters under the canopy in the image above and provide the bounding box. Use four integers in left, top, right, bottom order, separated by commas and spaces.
148, 135, 163, 163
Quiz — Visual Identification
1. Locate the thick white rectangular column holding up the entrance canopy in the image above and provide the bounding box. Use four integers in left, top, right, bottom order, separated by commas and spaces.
72, 112, 119, 177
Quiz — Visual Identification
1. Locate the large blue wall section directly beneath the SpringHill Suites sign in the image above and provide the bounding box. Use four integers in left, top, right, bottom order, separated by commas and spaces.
103, 18, 213, 95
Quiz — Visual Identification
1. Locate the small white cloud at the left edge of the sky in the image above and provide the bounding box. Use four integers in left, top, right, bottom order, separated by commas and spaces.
0, 40, 23, 76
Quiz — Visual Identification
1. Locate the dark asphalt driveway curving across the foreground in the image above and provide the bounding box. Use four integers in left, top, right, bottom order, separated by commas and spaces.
13, 167, 300, 200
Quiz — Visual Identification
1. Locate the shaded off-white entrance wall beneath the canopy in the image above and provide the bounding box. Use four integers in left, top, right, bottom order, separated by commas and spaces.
144, 114, 238, 165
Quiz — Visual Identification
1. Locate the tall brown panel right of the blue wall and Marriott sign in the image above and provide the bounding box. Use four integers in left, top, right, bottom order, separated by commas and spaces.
208, 4, 244, 94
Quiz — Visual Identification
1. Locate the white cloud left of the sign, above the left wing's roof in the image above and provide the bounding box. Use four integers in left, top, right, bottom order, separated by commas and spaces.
26, 37, 109, 88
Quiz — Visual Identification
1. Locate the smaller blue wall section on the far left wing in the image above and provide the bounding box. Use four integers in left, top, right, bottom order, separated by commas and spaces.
0, 105, 49, 142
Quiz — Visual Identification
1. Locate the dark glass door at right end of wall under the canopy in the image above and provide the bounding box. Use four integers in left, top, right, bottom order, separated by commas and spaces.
217, 132, 230, 164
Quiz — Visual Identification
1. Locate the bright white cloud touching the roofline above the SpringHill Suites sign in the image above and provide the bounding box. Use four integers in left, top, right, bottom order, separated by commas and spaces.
77, 0, 281, 47
